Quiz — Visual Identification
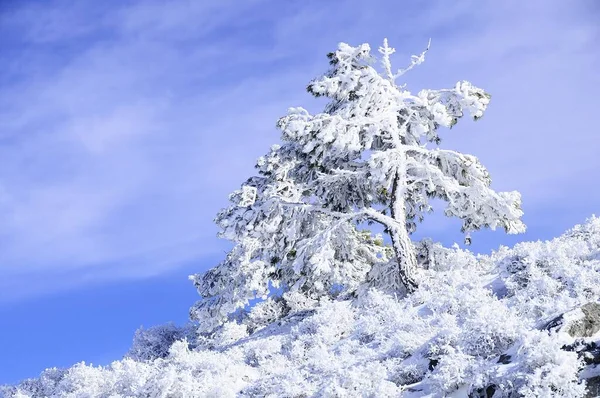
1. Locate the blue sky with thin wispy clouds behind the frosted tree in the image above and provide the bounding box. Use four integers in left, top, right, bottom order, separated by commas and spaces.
0, 0, 600, 383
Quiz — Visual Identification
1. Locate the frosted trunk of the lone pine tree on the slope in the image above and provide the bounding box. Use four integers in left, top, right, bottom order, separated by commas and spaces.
388, 171, 419, 293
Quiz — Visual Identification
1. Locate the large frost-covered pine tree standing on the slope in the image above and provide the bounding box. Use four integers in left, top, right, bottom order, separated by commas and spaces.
191, 41, 525, 330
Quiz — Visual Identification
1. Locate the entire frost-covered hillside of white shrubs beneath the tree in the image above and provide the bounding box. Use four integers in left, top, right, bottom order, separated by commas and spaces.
0, 217, 600, 398
